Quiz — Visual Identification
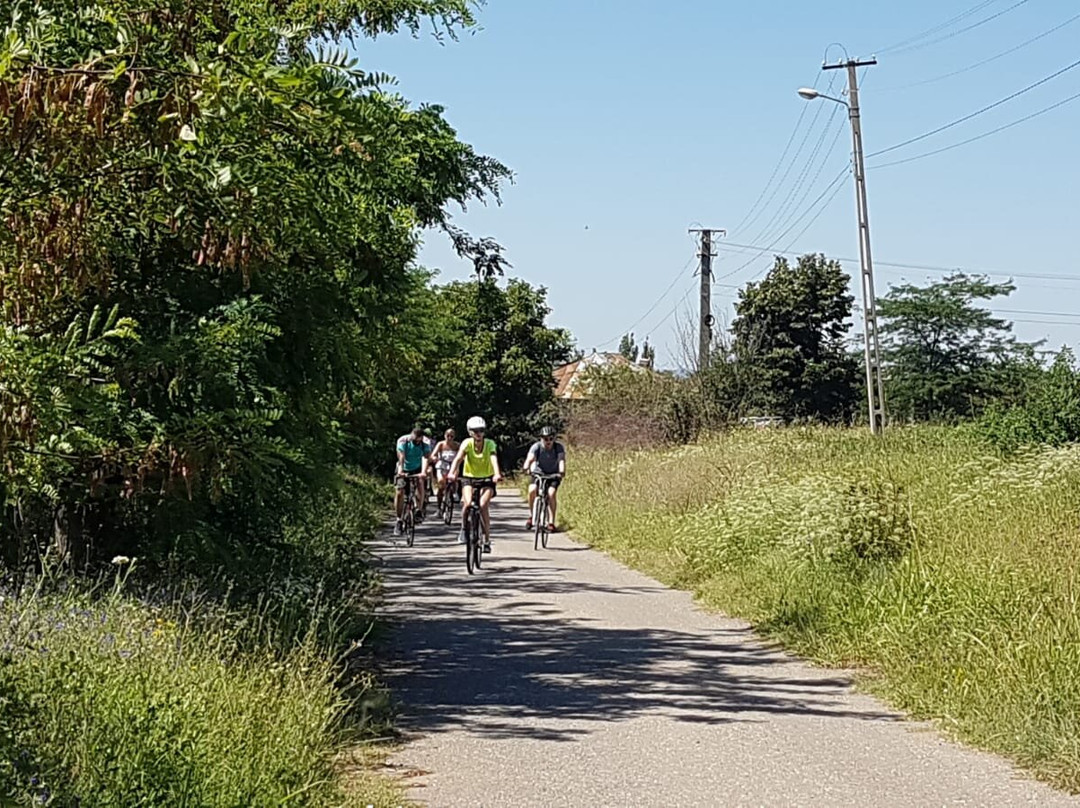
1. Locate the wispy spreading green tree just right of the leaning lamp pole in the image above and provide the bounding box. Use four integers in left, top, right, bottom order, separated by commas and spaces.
878, 273, 1034, 420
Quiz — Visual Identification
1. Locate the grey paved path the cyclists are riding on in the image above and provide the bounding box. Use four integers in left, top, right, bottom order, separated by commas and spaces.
375, 491, 1080, 808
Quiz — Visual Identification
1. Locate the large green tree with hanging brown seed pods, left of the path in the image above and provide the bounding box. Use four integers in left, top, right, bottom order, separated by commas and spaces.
0, 0, 509, 555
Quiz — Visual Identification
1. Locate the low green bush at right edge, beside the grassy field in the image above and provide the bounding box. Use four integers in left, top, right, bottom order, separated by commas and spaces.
976, 348, 1080, 452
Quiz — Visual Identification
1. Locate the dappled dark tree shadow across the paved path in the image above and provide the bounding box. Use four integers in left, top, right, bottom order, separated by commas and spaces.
375, 512, 895, 741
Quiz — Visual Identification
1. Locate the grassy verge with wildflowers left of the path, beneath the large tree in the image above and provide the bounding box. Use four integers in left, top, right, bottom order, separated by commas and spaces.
0, 479, 402, 807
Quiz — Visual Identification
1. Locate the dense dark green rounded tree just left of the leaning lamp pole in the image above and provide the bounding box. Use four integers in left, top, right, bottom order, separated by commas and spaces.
724, 255, 859, 421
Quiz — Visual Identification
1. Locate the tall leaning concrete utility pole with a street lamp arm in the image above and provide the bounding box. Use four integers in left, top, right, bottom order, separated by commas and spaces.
798, 60, 885, 434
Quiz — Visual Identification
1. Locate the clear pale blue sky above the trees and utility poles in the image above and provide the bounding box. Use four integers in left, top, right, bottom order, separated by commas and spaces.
356, 0, 1080, 365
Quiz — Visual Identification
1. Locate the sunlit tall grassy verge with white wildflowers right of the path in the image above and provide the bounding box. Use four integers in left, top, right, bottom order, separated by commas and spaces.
561, 428, 1080, 792
